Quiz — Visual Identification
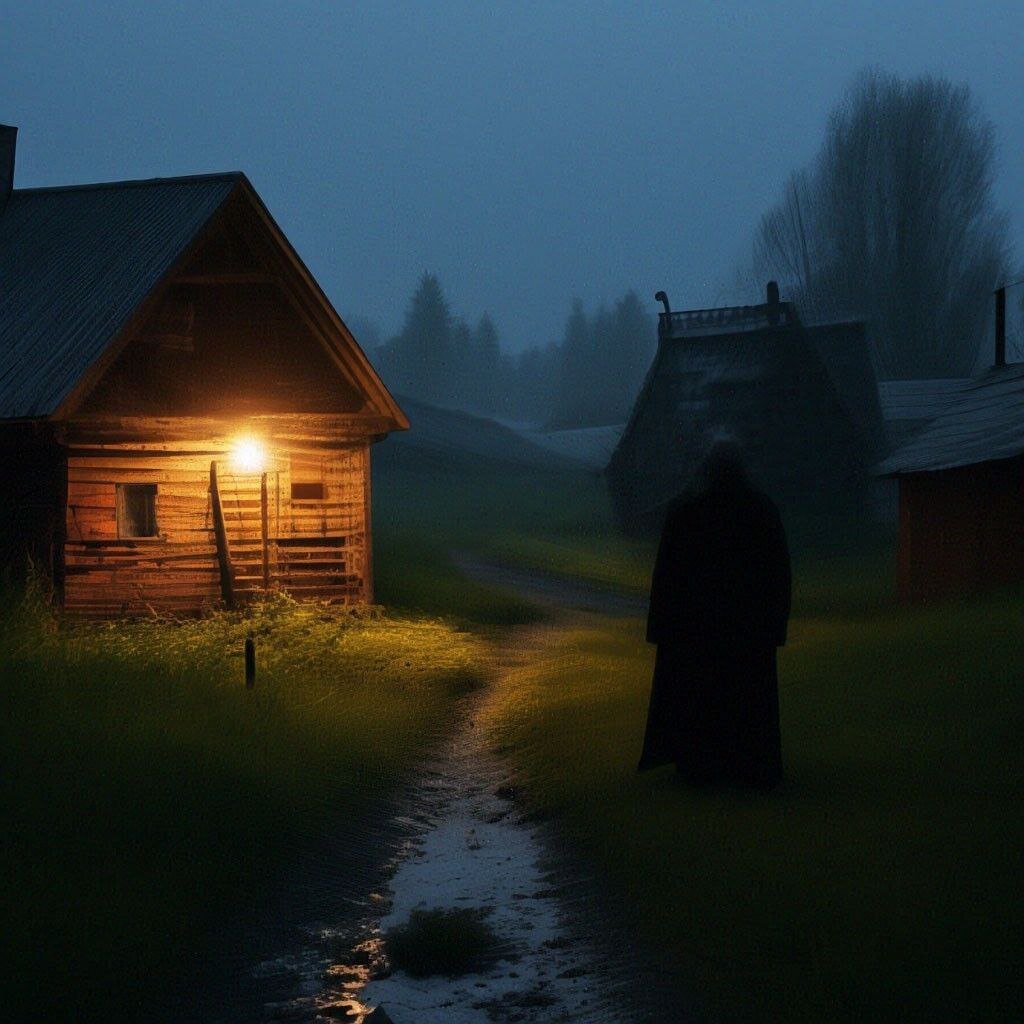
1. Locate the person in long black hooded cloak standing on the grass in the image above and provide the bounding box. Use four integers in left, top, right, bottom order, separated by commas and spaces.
639, 442, 792, 787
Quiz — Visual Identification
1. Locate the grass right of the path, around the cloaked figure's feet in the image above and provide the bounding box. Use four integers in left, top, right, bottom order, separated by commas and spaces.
479, 581, 1024, 1022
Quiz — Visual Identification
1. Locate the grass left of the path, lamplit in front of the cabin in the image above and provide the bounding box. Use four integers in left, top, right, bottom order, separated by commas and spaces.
0, 599, 482, 1020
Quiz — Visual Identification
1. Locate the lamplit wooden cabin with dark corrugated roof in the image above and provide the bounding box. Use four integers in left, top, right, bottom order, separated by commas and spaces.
0, 129, 409, 616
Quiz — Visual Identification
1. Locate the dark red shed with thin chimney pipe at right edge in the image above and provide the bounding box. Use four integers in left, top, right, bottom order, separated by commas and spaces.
879, 292, 1024, 601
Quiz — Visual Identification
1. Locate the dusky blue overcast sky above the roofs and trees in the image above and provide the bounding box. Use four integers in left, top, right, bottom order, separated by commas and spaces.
0, 0, 1024, 348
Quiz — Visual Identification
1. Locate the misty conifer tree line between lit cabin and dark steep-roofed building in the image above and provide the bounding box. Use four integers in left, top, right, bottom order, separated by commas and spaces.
368, 273, 656, 428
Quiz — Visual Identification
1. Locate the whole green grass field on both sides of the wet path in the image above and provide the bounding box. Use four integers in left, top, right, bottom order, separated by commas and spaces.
6, 454, 1024, 1022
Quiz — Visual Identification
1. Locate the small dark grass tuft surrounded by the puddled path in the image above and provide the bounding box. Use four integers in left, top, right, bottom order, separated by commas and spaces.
386, 907, 502, 978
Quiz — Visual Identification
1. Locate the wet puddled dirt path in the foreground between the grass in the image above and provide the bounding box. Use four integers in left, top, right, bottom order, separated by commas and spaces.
258, 675, 649, 1024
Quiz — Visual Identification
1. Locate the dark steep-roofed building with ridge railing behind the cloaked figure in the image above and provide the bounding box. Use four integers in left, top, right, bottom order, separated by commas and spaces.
606, 285, 886, 534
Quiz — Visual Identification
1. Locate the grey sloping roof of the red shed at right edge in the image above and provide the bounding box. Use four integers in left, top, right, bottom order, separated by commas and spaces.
877, 362, 1024, 476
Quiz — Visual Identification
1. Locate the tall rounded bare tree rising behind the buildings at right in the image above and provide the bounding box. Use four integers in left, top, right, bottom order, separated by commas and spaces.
753, 71, 1008, 378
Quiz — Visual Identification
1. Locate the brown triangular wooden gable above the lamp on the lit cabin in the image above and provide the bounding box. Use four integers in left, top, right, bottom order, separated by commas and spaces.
73, 200, 369, 419
